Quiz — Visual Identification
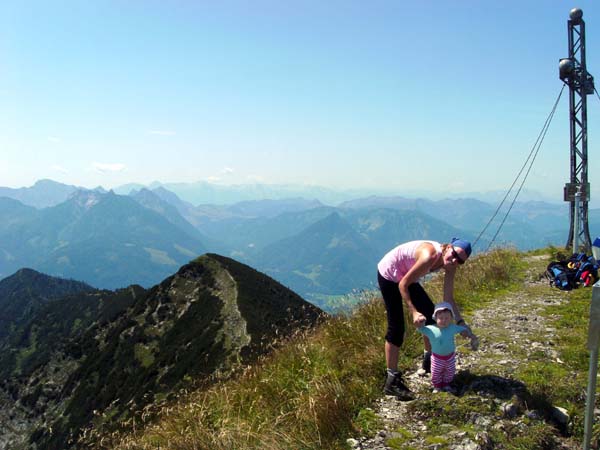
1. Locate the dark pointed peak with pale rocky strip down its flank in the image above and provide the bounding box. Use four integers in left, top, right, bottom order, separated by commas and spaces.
21, 254, 322, 449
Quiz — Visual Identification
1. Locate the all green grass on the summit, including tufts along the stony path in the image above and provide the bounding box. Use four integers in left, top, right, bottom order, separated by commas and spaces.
82, 249, 591, 450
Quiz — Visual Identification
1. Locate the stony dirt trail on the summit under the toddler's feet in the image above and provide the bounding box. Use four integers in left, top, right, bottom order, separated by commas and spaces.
348, 257, 591, 450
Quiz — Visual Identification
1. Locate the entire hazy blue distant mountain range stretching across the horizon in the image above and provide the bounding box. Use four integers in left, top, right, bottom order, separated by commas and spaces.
0, 180, 584, 308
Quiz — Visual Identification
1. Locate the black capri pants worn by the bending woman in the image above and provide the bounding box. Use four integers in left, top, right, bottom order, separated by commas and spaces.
377, 271, 435, 347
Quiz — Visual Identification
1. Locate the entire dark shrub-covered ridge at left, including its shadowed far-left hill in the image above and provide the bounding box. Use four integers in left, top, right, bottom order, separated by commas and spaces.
0, 254, 322, 449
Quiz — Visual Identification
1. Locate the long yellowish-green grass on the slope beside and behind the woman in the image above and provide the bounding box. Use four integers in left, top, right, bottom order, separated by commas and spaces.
81, 250, 556, 450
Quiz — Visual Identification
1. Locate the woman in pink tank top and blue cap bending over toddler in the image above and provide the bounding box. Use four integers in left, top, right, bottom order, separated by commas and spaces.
377, 238, 471, 400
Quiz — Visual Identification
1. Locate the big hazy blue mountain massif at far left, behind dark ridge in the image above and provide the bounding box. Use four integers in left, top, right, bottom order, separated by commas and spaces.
0, 190, 207, 288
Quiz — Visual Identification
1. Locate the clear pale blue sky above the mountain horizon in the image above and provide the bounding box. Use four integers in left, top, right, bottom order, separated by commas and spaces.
0, 0, 600, 201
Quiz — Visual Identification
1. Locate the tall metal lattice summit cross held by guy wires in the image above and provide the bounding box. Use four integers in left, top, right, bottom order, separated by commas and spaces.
559, 8, 594, 252
